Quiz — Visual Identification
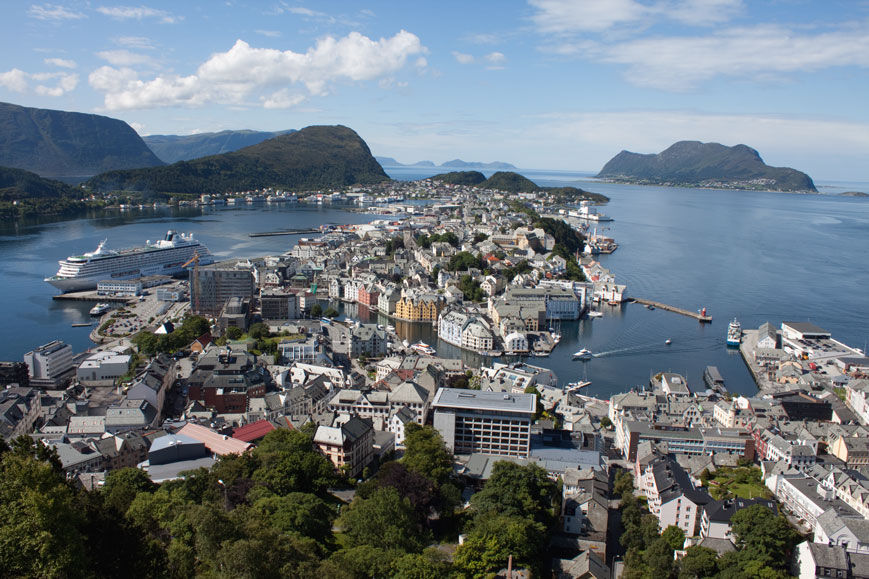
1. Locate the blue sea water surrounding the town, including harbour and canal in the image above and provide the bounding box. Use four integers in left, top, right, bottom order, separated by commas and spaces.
0, 167, 869, 398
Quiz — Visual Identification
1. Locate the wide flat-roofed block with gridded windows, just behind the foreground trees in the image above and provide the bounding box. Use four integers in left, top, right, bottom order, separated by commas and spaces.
432, 388, 537, 458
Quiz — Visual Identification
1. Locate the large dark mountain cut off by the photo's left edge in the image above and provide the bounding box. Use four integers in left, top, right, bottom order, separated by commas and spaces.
0, 103, 163, 178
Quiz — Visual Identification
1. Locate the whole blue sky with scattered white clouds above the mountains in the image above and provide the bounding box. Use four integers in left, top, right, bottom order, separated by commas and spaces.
0, 0, 869, 182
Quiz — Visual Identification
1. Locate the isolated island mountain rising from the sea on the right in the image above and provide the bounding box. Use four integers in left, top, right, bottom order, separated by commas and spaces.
597, 141, 817, 193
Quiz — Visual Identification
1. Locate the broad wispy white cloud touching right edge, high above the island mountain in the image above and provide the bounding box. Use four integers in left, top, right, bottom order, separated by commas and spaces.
600, 26, 869, 91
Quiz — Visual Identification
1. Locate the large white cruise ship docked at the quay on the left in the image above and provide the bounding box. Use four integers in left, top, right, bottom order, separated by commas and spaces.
45, 230, 214, 293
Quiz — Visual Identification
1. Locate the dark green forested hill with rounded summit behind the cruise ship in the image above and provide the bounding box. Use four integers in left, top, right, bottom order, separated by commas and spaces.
88, 125, 389, 194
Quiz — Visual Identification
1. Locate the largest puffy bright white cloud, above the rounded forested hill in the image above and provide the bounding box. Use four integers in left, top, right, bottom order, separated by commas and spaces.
89, 30, 427, 110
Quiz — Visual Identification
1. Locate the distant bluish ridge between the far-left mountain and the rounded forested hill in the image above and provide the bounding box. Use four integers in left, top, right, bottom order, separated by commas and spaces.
142, 129, 295, 163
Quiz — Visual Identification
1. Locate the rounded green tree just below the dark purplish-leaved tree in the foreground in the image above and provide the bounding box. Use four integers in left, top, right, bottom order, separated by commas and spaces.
339, 487, 426, 552
